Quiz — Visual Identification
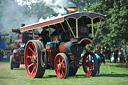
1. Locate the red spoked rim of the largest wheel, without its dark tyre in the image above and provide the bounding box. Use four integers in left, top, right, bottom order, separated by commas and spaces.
25, 41, 38, 78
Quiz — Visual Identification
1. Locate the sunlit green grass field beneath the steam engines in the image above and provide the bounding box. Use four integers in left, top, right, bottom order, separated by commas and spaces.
0, 61, 128, 85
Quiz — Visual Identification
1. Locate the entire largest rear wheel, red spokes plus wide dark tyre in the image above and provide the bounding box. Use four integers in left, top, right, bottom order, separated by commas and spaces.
25, 40, 45, 78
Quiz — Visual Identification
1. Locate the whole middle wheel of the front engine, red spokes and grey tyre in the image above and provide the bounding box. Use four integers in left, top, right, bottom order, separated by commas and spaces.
54, 53, 69, 79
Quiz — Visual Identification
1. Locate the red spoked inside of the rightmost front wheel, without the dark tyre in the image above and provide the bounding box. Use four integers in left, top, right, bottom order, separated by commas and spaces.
82, 53, 94, 76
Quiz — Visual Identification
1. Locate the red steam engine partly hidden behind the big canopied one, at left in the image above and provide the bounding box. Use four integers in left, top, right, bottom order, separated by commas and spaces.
10, 24, 38, 69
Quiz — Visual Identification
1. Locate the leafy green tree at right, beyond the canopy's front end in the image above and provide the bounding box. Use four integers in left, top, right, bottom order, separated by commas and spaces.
85, 0, 128, 47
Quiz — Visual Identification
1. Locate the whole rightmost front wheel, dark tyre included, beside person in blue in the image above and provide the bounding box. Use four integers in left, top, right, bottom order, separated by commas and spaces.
82, 52, 98, 76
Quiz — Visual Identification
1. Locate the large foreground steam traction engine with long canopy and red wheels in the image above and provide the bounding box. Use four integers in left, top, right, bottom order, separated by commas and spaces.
21, 12, 105, 79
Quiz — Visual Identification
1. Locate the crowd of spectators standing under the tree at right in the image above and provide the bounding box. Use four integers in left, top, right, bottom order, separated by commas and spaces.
94, 46, 128, 73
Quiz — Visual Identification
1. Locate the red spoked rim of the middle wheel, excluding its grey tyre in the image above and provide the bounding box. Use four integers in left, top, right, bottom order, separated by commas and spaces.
54, 55, 66, 78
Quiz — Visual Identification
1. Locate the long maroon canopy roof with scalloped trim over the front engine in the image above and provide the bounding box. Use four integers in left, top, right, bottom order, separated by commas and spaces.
20, 12, 105, 32
